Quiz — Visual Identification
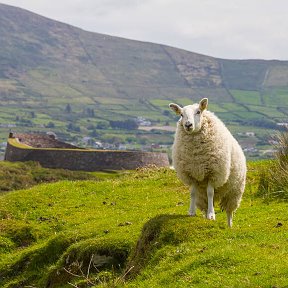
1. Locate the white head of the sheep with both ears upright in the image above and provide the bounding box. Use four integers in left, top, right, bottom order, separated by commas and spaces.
169, 98, 208, 134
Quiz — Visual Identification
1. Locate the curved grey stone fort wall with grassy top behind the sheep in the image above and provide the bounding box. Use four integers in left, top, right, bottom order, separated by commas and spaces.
5, 134, 169, 171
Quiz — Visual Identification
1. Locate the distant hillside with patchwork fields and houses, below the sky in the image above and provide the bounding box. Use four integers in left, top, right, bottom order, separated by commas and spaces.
0, 4, 288, 158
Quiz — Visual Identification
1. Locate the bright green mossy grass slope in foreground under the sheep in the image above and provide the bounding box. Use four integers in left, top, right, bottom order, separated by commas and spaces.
0, 162, 288, 287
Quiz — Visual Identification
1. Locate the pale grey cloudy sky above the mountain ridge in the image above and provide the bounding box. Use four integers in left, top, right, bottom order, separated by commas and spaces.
0, 0, 288, 60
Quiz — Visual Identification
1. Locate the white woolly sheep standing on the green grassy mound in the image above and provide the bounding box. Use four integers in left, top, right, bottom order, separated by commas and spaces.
169, 98, 247, 227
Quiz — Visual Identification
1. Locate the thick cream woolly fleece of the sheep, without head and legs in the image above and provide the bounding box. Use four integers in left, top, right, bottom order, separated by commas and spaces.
172, 110, 246, 217
